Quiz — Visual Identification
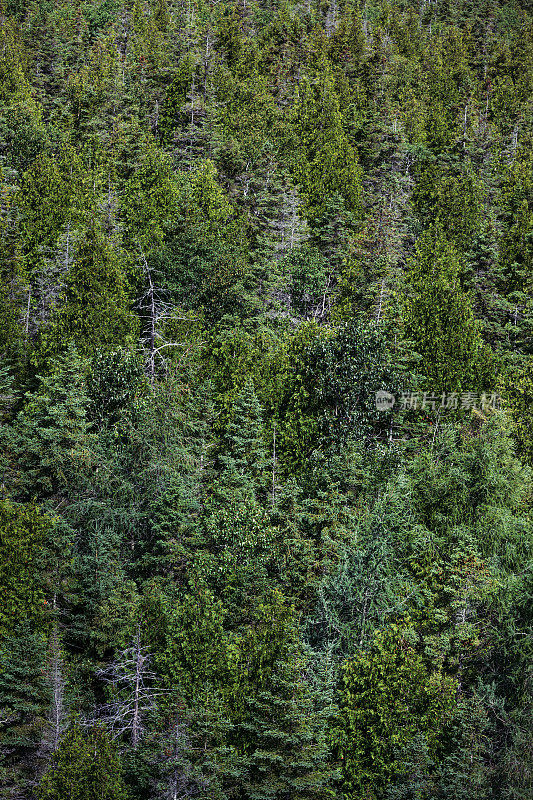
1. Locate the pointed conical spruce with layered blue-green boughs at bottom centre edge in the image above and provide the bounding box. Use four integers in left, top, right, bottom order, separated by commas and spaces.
232, 591, 332, 800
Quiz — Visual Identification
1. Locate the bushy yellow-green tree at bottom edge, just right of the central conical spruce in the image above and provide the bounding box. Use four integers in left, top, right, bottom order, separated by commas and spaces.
337, 625, 457, 800
